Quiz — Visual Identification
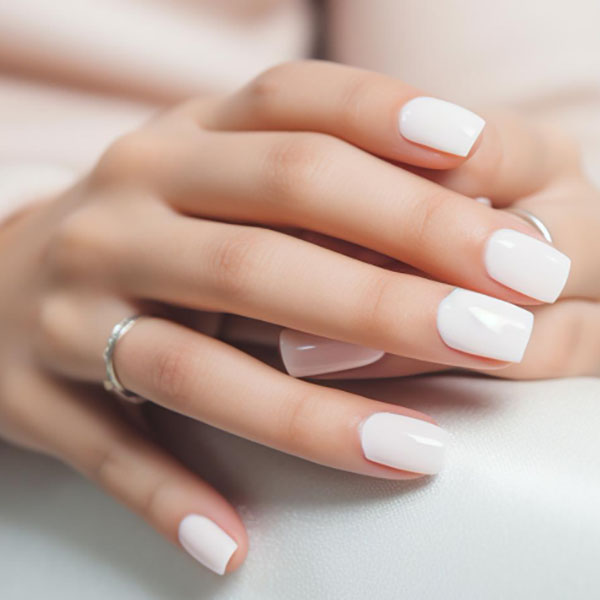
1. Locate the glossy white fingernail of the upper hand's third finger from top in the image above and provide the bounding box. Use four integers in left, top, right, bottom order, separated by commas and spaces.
437, 288, 533, 363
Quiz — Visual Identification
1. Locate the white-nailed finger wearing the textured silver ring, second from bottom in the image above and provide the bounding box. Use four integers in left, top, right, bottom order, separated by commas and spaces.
115, 318, 445, 479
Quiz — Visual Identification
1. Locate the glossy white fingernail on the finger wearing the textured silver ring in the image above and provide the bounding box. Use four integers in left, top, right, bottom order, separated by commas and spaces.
360, 412, 448, 475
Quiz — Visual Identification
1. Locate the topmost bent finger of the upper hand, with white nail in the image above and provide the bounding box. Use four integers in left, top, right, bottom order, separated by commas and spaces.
192, 61, 485, 169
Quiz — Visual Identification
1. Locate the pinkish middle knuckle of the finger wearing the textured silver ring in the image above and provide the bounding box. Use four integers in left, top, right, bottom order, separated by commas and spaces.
150, 344, 195, 412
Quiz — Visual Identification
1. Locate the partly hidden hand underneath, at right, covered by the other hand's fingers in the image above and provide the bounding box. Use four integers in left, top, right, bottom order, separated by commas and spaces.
268, 109, 600, 379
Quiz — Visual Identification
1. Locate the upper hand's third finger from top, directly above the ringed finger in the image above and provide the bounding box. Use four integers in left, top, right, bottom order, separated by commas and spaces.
109, 216, 532, 368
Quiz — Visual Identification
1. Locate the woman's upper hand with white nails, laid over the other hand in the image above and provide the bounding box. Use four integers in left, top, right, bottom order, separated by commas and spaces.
0, 63, 568, 572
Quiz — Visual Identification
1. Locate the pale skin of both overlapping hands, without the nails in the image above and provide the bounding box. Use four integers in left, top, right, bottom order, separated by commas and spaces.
0, 62, 600, 571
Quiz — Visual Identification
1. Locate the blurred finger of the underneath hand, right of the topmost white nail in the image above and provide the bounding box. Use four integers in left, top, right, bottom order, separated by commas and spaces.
415, 113, 579, 207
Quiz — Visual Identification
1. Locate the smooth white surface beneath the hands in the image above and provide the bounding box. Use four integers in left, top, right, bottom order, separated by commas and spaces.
0, 376, 600, 600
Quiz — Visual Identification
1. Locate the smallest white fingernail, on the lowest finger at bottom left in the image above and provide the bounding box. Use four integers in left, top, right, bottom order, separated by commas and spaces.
179, 515, 237, 575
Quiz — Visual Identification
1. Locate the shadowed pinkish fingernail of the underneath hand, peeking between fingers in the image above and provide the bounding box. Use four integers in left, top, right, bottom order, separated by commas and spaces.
279, 329, 384, 377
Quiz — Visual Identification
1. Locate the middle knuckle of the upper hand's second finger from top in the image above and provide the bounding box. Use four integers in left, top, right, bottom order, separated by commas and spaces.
263, 133, 338, 208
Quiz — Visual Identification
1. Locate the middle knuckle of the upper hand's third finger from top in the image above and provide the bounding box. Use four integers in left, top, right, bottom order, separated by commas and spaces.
209, 229, 270, 299
